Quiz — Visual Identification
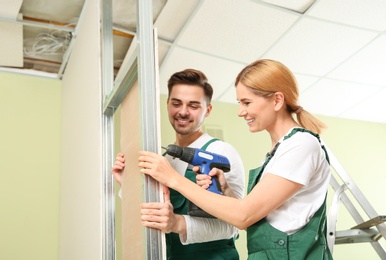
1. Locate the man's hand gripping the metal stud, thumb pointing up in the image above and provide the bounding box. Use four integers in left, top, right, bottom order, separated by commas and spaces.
141, 186, 186, 237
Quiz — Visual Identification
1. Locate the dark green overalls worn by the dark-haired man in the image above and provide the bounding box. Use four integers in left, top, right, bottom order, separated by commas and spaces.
166, 139, 239, 260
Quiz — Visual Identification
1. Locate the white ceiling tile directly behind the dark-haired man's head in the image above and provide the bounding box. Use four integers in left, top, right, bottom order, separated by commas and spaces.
160, 47, 244, 101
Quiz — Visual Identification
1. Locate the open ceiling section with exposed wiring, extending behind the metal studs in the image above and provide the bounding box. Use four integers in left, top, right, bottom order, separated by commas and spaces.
0, 0, 166, 78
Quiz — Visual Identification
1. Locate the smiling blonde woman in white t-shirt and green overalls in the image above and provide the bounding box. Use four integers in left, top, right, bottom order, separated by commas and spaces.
139, 60, 332, 259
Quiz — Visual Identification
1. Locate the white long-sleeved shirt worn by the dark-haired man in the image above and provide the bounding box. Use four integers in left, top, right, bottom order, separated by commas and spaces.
165, 134, 245, 245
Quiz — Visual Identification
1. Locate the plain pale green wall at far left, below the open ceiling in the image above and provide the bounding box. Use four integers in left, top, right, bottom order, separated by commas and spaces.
0, 72, 62, 260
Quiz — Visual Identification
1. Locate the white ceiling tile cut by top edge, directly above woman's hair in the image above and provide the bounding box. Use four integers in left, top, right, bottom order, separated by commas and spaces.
176, 0, 299, 63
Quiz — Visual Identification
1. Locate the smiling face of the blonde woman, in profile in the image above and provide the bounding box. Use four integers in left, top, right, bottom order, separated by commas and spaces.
236, 83, 276, 132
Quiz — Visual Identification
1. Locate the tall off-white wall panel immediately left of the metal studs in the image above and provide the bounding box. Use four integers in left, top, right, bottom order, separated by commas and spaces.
59, 0, 103, 260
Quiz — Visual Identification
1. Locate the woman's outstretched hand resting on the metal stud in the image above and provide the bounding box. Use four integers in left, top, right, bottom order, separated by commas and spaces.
138, 151, 182, 188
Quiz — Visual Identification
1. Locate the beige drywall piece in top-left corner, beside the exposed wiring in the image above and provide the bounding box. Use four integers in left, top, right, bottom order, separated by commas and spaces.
0, 0, 24, 67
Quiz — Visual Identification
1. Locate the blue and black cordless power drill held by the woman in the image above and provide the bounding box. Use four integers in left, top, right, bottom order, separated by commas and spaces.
165, 144, 231, 218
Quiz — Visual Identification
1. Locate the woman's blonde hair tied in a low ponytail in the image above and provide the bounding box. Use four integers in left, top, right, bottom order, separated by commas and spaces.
235, 59, 326, 134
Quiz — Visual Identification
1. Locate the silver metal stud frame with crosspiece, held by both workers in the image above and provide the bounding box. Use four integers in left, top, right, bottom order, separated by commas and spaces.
101, 0, 165, 260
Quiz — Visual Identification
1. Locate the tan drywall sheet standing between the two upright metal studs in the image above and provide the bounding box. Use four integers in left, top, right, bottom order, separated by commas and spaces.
121, 81, 146, 260
